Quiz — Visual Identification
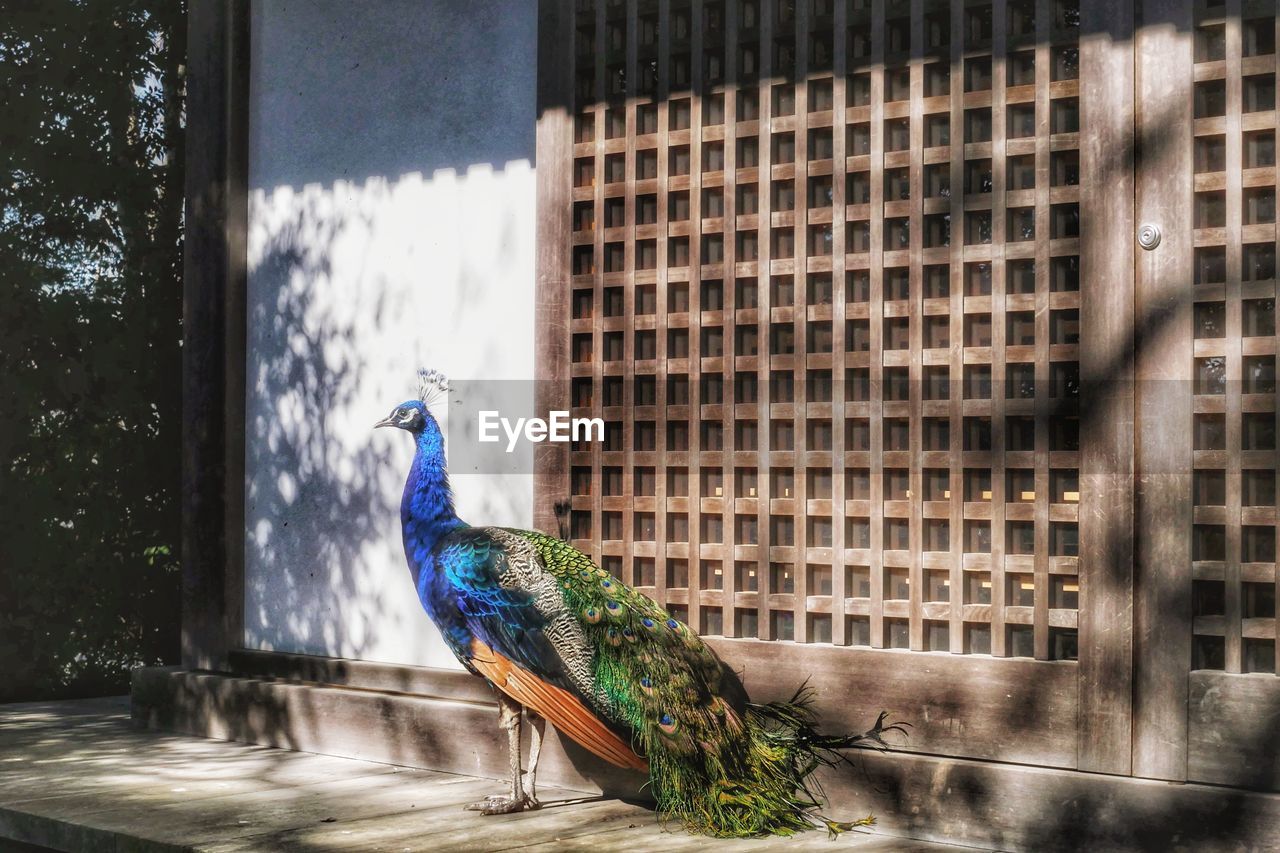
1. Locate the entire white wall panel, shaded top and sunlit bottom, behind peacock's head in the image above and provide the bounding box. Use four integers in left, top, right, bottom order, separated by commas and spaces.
244, 0, 536, 666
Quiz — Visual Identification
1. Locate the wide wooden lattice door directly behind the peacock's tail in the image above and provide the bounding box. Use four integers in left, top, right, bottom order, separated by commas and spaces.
539, 0, 1134, 774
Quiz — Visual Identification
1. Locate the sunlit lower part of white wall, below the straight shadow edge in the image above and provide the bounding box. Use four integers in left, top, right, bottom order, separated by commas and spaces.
244, 163, 532, 667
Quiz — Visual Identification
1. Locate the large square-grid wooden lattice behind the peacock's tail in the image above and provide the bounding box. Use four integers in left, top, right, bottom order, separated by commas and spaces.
560, 0, 1080, 660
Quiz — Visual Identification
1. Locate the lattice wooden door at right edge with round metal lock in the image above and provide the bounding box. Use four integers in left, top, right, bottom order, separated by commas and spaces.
1134, 0, 1280, 790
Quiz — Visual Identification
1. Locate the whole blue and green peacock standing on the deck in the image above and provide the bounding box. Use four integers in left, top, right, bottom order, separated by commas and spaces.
376, 370, 905, 838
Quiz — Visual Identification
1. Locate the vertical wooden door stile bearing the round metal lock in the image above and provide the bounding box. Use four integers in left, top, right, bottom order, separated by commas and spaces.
1133, 0, 1193, 780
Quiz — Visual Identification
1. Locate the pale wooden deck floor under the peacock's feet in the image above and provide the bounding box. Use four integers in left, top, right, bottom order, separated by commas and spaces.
0, 698, 972, 853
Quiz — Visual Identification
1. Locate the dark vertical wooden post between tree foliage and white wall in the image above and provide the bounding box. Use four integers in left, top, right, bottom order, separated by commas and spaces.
182, 0, 250, 670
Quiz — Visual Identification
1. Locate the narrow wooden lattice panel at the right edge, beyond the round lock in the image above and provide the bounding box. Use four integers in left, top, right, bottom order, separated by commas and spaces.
1188, 1, 1277, 672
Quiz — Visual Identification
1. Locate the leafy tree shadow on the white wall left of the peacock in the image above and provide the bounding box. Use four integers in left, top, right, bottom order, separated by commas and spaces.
246, 185, 397, 657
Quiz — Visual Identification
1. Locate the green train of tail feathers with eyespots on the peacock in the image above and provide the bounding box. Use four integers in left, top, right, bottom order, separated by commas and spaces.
512, 530, 905, 838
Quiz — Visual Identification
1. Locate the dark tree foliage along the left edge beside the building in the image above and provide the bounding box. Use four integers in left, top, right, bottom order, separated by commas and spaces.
0, 0, 186, 702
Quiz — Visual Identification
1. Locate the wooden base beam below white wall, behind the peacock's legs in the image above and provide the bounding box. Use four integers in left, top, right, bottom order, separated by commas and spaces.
133, 653, 645, 798
